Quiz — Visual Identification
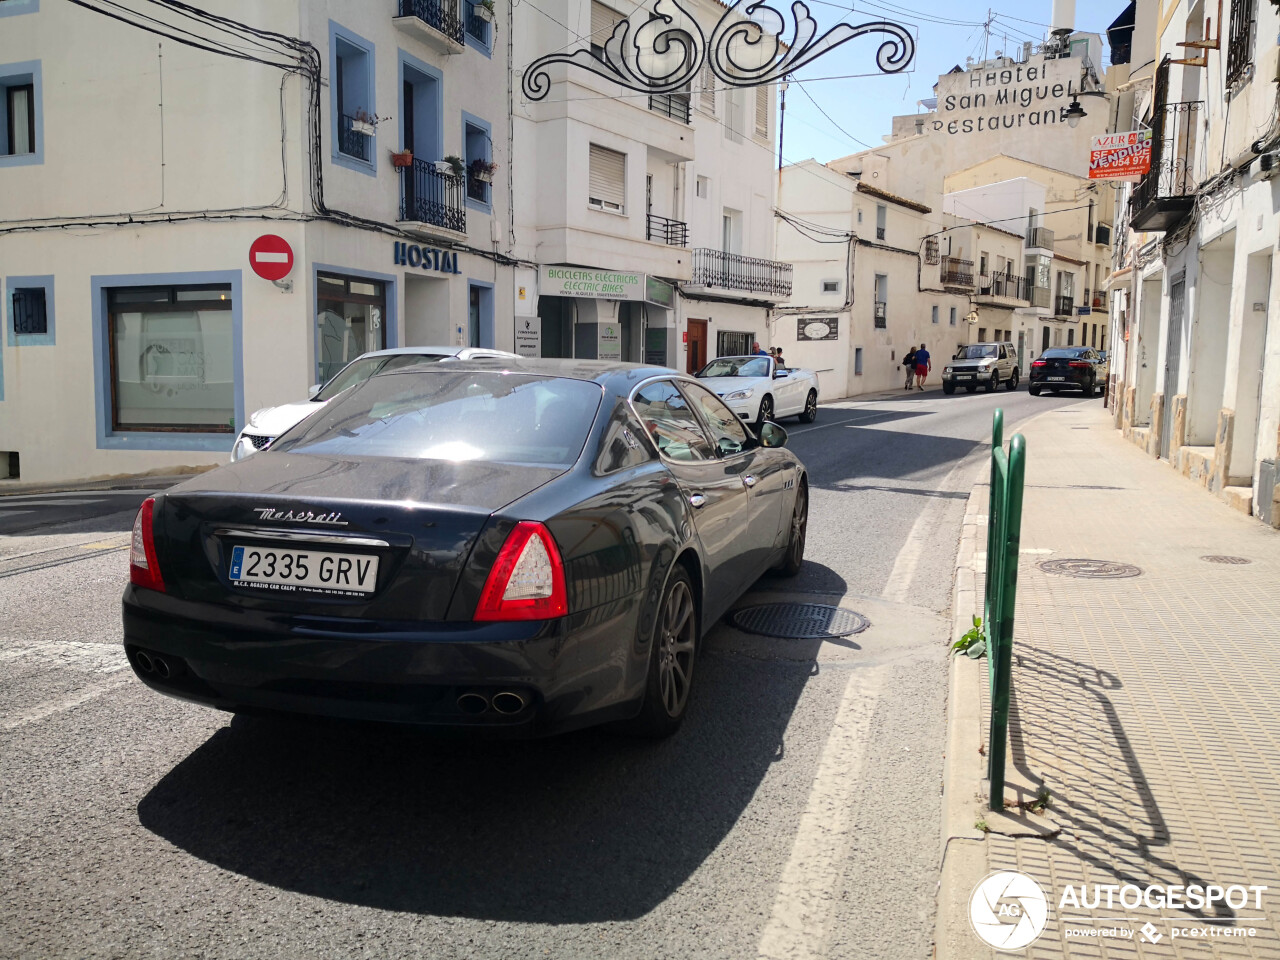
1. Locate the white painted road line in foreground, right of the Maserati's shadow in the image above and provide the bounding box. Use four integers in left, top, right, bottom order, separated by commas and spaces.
756, 667, 887, 960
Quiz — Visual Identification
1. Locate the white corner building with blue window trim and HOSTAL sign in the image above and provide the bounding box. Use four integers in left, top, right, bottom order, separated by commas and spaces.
0, 0, 515, 483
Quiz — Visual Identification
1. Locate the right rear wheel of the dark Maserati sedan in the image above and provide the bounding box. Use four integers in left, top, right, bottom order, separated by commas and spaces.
618, 563, 700, 739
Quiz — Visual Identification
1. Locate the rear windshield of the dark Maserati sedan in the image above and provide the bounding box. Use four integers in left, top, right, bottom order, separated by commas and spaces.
271, 371, 604, 466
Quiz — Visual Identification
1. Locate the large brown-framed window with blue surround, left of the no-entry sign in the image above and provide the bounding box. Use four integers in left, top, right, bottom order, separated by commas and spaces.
106, 284, 236, 434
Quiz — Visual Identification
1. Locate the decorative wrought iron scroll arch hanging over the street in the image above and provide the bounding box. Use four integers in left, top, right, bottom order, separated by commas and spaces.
521, 0, 915, 100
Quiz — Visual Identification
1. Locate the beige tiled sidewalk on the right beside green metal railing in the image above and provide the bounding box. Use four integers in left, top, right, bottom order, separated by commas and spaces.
938, 403, 1280, 957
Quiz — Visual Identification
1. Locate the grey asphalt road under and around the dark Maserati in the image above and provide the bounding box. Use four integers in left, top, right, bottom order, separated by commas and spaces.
0, 390, 1080, 960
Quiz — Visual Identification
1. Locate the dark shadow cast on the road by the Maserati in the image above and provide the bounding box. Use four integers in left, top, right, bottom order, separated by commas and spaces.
137, 571, 847, 923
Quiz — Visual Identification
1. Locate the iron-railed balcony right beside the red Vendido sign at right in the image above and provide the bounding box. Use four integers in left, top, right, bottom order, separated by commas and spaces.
1129, 100, 1204, 233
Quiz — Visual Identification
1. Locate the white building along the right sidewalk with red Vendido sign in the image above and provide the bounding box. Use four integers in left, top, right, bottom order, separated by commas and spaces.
1110, 0, 1280, 526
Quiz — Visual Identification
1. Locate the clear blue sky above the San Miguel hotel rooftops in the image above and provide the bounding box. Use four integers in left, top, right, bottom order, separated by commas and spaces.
771, 0, 1128, 163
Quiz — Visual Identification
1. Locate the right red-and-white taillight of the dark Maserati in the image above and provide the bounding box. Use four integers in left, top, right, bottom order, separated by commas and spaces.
475, 520, 568, 620
